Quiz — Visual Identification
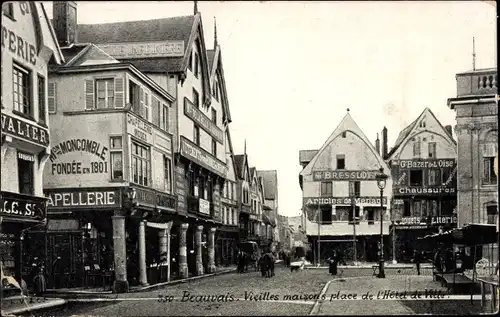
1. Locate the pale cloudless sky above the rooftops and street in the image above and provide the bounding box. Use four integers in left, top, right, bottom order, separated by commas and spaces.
44, 1, 497, 216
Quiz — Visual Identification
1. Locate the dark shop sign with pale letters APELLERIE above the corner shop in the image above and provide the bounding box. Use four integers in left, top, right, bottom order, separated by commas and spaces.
45, 187, 121, 209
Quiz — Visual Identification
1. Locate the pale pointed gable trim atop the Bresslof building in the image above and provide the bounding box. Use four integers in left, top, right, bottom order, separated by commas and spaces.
299, 113, 390, 176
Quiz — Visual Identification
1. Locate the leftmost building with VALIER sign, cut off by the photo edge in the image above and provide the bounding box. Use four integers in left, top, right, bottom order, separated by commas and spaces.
0, 1, 64, 292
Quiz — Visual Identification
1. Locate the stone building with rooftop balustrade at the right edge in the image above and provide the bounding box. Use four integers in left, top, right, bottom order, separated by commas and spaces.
448, 68, 498, 263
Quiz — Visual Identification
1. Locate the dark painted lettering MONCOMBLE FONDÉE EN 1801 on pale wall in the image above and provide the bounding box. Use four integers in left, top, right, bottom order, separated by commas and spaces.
49, 138, 108, 175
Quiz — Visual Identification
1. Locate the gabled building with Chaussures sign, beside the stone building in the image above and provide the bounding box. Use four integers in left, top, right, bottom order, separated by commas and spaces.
381, 108, 457, 262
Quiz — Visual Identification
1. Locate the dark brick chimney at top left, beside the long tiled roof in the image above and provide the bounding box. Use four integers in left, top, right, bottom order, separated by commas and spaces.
52, 1, 78, 47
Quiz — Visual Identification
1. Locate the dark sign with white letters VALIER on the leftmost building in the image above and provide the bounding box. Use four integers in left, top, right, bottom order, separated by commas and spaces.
2, 113, 49, 147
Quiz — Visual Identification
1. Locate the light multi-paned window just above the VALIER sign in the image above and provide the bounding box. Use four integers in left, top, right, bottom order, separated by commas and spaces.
12, 64, 33, 116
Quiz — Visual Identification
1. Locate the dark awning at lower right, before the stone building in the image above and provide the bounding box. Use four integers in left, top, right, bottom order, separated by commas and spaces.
418, 224, 498, 246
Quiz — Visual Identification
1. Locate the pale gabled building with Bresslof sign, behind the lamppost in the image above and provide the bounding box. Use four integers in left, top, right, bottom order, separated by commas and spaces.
299, 113, 392, 262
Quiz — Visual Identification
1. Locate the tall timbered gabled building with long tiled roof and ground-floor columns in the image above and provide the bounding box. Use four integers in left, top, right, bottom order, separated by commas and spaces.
77, 5, 230, 277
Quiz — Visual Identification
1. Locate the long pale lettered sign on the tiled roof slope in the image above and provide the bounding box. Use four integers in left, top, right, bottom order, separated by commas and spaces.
97, 40, 184, 58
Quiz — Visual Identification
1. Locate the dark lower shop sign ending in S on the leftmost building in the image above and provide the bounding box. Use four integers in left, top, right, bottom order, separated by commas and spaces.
0, 192, 46, 220
